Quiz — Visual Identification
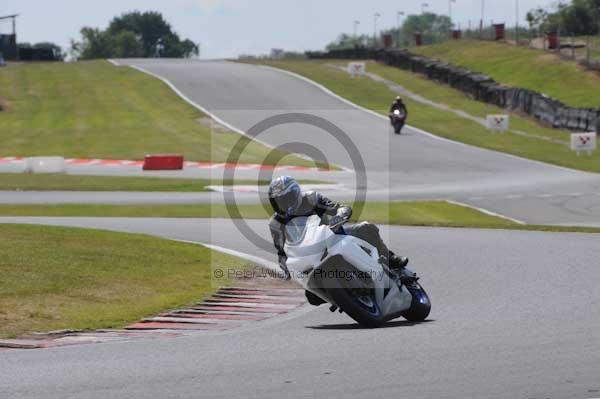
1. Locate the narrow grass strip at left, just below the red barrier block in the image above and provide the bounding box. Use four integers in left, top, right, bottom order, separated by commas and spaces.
0, 173, 323, 192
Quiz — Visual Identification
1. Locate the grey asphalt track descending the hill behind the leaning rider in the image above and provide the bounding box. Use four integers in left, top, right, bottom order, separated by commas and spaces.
0, 60, 600, 226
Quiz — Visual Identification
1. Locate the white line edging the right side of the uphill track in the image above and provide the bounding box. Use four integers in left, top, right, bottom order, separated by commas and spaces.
256, 65, 591, 174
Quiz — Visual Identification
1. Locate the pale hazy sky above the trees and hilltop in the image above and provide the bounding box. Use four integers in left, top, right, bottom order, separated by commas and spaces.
0, 0, 556, 58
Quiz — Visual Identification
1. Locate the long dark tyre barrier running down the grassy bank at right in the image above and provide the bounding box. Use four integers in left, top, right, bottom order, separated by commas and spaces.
372, 49, 600, 131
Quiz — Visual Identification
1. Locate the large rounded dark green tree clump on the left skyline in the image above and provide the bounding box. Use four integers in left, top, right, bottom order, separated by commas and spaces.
71, 11, 199, 59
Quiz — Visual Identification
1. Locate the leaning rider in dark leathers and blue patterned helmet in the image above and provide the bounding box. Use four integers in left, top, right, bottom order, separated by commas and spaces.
269, 176, 408, 296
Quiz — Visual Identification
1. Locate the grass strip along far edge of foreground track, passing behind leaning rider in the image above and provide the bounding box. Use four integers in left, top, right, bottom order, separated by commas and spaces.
0, 201, 600, 233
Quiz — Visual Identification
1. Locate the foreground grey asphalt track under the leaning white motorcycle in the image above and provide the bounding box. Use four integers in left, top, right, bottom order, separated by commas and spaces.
0, 218, 600, 399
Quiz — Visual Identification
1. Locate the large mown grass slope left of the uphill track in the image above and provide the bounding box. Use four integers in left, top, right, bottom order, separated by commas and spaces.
0, 61, 312, 165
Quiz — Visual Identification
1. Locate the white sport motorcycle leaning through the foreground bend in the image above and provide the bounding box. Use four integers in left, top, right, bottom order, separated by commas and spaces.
285, 215, 431, 327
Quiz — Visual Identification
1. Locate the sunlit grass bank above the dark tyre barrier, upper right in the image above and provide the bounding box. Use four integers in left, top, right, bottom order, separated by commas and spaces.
411, 40, 600, 108
